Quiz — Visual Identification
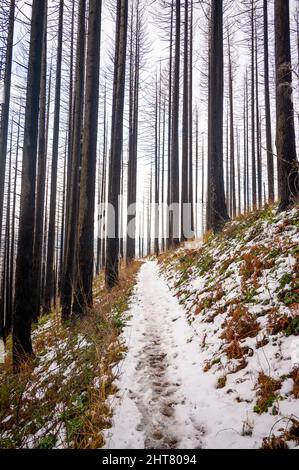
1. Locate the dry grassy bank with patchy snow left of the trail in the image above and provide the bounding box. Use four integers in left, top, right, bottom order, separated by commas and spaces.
0, 263, 140, 448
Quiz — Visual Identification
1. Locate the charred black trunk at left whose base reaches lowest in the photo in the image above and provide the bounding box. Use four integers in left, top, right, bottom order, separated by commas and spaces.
13, 0, 46, 371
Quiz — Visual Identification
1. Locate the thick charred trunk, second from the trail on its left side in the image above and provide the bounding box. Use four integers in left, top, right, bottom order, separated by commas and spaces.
73, 0, 102, 315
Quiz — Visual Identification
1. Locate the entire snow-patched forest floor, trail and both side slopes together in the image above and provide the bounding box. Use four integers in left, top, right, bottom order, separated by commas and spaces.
0, 206, 299, 449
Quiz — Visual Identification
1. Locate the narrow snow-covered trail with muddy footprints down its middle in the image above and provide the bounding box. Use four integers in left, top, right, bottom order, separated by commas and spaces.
105, 261, 205, 449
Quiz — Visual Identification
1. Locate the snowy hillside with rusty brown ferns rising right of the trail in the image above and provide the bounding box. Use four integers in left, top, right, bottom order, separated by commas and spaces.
160, 207, 299, 448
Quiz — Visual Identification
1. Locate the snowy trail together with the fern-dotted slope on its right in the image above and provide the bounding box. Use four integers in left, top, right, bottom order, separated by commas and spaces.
104, 207, 299, 449
